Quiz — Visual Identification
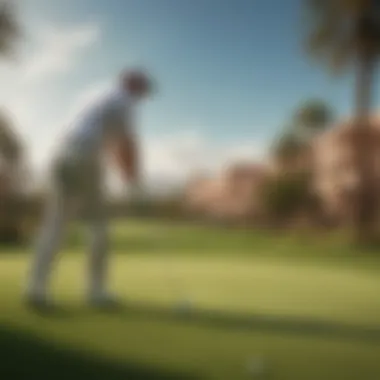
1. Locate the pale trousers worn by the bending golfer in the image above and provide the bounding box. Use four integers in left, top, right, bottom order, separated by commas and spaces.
27, 154, 108, 297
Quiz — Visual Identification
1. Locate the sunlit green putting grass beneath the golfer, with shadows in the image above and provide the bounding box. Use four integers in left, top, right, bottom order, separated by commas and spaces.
0, 221, 380, 380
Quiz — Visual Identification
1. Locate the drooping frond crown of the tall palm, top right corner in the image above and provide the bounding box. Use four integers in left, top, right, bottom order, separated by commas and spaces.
304, 0, 380, 74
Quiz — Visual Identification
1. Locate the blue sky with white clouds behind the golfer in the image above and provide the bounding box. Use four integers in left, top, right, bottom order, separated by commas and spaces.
0, 0, 364, 186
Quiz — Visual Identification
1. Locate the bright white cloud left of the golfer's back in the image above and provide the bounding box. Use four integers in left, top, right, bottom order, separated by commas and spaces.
0, 23, 101, 181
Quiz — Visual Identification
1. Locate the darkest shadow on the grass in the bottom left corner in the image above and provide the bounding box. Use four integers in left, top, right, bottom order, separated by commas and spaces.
0, 327, 196, 380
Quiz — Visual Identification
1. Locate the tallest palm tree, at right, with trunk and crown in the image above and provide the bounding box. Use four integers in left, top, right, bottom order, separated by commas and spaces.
305, 0, 380, 242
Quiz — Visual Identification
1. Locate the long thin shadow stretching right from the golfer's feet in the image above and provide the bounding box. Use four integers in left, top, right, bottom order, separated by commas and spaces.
44, 303, 380, 345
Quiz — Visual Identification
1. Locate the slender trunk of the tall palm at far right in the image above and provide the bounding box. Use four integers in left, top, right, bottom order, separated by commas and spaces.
353, 54, 377, 244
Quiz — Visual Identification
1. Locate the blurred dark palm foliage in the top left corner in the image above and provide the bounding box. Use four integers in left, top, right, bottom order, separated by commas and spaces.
0, 0, 20, 57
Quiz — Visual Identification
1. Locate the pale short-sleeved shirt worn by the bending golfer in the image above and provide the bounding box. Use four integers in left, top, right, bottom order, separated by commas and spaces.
59, 87, 133, 160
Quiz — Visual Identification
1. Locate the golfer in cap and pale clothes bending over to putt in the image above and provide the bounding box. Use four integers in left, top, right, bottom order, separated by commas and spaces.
26, 70, 152, 308
